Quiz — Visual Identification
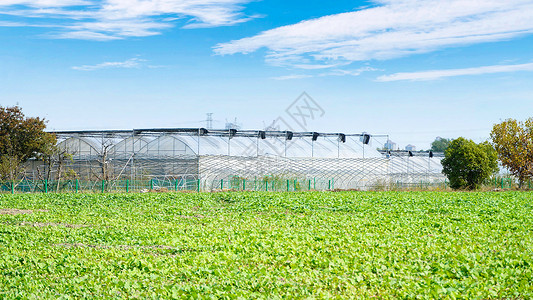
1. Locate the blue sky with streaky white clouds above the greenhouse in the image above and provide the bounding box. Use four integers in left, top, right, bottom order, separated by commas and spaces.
0, 0, 533, 149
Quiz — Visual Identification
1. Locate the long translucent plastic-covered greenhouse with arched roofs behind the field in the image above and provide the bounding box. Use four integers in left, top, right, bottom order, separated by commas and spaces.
22, 128, 444, 191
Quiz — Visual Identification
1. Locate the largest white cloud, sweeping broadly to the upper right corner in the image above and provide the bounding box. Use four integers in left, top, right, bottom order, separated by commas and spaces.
214, 0, 533, 67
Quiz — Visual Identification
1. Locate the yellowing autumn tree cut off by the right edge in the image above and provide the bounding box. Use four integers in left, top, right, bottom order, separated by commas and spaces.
490, 118, 533, 187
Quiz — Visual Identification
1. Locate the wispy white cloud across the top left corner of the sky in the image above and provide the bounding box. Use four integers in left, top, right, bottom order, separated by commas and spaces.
0, 0, 252, 41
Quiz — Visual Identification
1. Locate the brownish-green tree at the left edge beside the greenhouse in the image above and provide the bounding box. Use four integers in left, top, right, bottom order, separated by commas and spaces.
0, 106, 56, 181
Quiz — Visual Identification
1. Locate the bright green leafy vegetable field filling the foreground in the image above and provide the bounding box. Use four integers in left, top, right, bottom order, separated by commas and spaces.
0, 192, 533, 299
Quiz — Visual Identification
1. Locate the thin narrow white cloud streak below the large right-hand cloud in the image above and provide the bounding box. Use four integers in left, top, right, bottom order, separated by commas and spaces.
377, 63, 533, 81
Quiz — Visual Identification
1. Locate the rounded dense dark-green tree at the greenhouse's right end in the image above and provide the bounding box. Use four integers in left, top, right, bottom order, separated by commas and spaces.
442, 137, 498, 190
